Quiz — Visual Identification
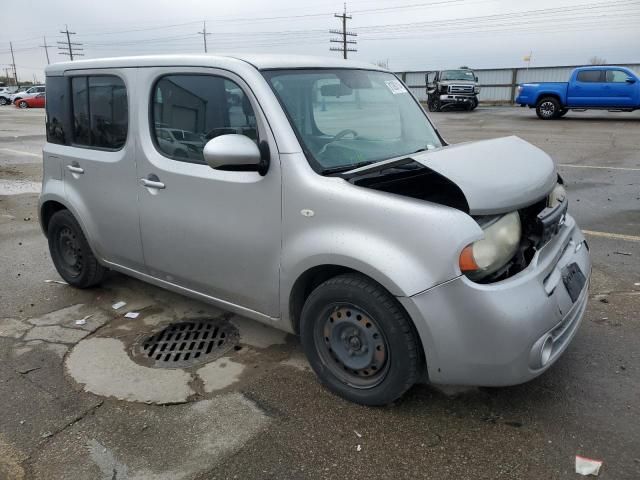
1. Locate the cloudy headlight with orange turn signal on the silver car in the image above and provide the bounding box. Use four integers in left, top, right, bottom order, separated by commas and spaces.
460, 212, 522, 280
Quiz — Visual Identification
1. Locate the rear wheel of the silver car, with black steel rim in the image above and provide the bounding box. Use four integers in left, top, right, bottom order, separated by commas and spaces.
47, 210, 106, 288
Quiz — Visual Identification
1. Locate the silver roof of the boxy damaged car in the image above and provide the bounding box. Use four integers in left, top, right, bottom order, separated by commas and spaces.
45, 53, 386, 75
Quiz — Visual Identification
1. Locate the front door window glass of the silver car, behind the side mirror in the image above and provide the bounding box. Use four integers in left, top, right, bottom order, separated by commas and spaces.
151, 74, 258, 163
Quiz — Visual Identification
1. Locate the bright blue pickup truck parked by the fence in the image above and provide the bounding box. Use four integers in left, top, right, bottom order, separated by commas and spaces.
516, 66, 640, 120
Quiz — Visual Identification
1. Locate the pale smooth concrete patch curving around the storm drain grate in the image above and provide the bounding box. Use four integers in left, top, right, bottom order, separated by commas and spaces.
66, 338, 195, 404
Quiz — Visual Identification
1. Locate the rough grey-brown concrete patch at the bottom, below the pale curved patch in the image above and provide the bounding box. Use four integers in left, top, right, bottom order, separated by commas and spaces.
32, 393, 269, 480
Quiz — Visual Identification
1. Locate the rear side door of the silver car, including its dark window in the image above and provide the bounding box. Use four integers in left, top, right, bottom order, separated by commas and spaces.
60, 69, 144, 270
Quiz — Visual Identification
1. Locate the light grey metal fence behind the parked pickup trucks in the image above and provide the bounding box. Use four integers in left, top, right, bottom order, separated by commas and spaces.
398, 63, 640, 103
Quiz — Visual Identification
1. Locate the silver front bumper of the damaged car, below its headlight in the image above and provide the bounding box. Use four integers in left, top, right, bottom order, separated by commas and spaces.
399, 215, 591, 386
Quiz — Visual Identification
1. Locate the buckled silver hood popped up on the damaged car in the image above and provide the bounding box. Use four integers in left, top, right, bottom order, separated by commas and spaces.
412, 136, 558, 215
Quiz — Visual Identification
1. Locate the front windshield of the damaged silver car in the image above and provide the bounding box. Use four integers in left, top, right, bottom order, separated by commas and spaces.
265, 69, 441, 173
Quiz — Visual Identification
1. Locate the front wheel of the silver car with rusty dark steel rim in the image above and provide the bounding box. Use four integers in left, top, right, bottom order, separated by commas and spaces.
300, 274, 422, 405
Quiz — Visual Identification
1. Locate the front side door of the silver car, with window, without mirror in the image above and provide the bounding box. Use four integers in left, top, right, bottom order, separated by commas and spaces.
137, 68, 281, 317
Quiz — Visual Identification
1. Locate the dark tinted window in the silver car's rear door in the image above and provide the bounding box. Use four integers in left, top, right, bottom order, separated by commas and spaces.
71, 75, 129, 150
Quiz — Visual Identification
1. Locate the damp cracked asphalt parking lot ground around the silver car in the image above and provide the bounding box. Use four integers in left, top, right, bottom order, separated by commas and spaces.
0, 107, 640, 480
